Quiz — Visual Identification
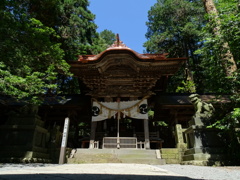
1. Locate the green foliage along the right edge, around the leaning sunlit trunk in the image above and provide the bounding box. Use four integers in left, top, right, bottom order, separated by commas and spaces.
196, 0, 240, 163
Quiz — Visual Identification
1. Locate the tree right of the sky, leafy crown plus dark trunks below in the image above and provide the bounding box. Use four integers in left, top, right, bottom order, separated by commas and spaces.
144, 0, 206, 92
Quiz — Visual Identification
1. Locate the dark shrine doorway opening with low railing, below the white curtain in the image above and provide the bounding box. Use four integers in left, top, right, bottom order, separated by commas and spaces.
95, 117, 145, 149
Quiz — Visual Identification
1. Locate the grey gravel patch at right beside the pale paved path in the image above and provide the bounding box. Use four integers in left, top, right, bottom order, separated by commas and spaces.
158, 164, 240, 180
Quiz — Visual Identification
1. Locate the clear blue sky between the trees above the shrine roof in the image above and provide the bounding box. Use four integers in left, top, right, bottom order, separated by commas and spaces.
89, 0, 157, 53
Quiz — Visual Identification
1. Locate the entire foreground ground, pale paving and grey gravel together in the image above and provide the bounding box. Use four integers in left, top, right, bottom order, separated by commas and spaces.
0, 163, 240, 180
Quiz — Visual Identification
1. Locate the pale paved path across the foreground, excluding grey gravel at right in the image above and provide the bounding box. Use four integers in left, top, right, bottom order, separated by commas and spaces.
0, 163, 194, 180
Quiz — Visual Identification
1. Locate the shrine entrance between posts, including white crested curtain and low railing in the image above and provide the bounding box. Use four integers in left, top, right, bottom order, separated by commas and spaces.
89, 97, 150, 149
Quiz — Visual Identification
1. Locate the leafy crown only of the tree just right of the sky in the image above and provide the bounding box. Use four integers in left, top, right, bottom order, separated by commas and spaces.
144, 0, 203, 57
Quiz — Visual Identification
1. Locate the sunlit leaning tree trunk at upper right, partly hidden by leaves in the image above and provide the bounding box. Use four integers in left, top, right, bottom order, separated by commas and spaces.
203, 0, 237, 76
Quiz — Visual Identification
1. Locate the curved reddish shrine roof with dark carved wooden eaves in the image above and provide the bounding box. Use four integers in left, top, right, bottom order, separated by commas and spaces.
69, 36, 187, 97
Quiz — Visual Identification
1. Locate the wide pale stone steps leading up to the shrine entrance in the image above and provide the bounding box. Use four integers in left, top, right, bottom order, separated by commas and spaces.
67, 149, 165, 165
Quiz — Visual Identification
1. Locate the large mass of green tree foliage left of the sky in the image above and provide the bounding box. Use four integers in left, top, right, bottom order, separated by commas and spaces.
0, 0, 99, 104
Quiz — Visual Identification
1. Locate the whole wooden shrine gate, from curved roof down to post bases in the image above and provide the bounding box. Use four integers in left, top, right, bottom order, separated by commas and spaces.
69, 35, 186, 149
